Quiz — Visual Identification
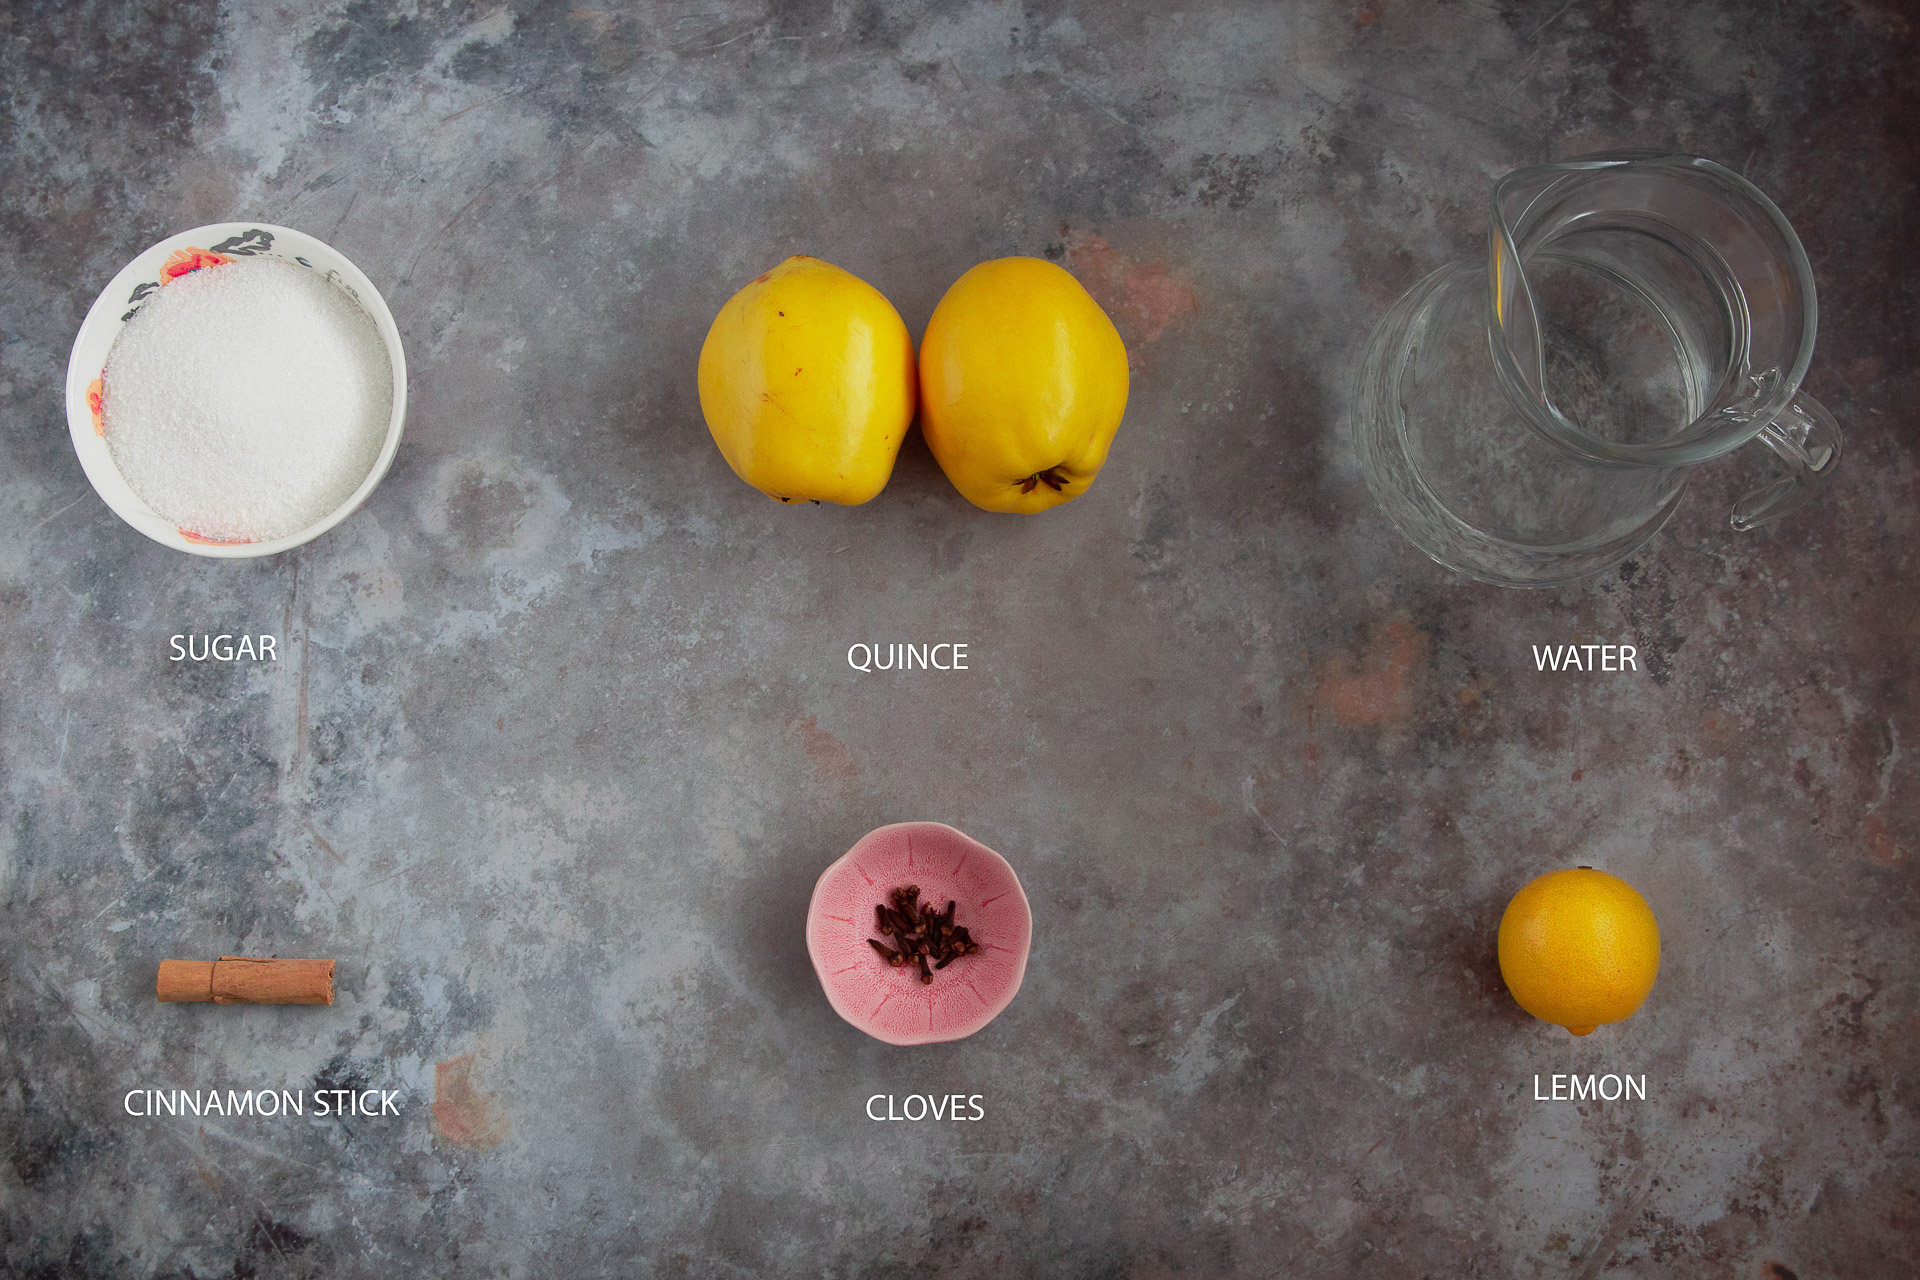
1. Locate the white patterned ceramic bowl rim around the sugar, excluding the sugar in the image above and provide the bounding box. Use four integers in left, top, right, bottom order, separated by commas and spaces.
67, 223, 407, 560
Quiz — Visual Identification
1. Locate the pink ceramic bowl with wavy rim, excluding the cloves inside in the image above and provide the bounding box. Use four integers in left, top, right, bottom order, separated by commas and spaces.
806, 821, 1033, 1044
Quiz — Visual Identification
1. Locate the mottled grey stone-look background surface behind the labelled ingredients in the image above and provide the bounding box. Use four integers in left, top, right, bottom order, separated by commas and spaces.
0, 0, 1920, 1280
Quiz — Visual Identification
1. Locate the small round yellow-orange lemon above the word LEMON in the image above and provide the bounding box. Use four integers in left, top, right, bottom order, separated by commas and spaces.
1500, 867, 1661, 1036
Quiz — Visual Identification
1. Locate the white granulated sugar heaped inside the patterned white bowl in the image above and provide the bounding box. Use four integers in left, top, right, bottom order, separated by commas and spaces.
102, 257, 394, 541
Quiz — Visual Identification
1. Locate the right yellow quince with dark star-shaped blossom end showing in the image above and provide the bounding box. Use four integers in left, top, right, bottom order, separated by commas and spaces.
920, 257, 1127, 512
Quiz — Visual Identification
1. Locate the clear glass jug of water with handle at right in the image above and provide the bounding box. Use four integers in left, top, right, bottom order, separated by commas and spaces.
1354, 152, 1839, 587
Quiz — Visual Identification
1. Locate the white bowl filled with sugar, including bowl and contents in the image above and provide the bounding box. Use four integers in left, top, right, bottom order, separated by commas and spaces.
67, 223, 407, 558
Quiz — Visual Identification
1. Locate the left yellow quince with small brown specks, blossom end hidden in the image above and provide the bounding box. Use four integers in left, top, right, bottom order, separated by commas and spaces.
699, 257, 918, 507
